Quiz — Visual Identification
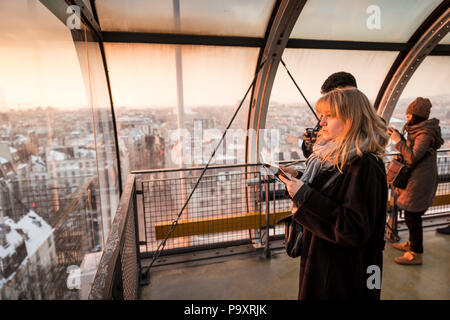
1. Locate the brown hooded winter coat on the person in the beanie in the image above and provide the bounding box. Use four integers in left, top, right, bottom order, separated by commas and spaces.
395, 119, 444, 212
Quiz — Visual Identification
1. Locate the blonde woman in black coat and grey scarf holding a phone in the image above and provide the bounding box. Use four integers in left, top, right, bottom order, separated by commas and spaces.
280, 87, 389, 299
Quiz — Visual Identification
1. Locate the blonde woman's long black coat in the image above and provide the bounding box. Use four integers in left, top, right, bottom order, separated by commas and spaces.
293, 154, 388, 299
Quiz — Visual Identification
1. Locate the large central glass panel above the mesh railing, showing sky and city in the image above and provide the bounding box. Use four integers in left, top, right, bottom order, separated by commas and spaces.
105, 43, 258, 179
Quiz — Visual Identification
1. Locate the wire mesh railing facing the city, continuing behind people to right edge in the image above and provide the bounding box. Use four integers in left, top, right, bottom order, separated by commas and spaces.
134, 150, 450, 257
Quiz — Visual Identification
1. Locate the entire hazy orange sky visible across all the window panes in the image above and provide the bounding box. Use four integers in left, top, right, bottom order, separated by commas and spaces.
0, 0, 450, 108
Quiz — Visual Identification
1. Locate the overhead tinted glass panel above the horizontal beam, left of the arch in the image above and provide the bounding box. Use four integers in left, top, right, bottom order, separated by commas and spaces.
96, 0, 275, 37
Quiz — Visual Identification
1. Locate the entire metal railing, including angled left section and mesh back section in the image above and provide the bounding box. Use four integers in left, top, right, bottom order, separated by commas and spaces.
90, 150, 450, 299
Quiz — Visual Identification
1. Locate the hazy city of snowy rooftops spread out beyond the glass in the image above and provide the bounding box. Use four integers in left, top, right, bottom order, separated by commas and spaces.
0, 96, 450, 299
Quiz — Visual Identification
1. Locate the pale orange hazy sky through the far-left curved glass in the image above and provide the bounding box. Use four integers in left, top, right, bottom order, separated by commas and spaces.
0, 0, 87, 107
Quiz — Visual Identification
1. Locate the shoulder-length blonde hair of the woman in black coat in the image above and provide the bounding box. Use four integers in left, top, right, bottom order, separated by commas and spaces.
316, 87, 389, 172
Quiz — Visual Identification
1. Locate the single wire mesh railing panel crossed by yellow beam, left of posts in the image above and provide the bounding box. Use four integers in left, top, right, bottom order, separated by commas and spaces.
140, 166, 260, 253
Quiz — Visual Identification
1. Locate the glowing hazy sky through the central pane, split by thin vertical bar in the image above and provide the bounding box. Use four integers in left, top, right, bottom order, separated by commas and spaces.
105, 43, 259, 107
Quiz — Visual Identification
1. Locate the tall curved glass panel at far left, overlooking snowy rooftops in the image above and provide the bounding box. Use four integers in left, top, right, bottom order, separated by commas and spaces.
0, 0, 117, 299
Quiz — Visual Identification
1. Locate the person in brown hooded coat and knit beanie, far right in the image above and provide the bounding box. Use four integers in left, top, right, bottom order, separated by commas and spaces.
388, 97, 444, 265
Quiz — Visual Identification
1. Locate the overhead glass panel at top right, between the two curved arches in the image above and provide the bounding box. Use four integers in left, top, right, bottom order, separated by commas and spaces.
291, 0, 441, 42
